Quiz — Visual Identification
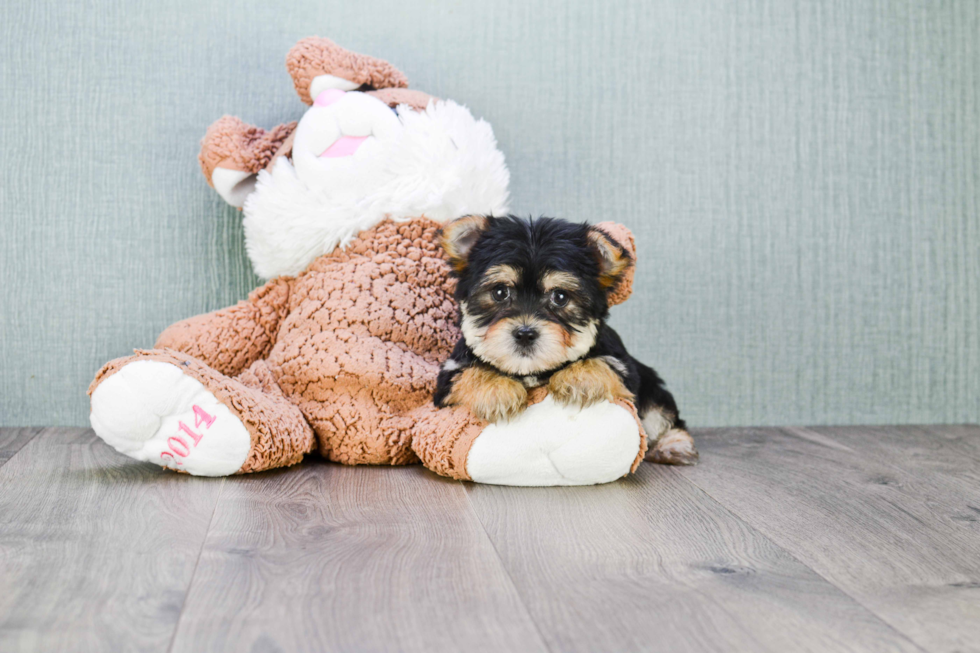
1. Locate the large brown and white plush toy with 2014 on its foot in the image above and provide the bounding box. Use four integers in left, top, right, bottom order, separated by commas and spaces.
89, 38, 659, 485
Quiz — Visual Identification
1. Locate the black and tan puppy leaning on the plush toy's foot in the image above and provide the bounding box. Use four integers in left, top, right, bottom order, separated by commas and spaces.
435, 216, 698, 464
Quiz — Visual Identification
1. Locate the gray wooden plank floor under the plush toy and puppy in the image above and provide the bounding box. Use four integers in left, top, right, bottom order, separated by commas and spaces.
0, 426, 980, 653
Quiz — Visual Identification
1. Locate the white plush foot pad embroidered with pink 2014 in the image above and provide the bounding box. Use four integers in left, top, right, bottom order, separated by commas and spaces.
90, 360, 252, 476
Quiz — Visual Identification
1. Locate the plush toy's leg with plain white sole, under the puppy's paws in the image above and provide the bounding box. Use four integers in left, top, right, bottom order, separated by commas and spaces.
412, 395, 646, 486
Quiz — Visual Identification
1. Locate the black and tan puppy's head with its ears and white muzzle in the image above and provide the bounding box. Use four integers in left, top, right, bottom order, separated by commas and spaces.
443, 216, 630, 376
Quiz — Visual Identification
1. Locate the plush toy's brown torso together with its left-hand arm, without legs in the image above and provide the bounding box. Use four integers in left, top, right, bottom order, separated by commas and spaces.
156, 220, 458, 464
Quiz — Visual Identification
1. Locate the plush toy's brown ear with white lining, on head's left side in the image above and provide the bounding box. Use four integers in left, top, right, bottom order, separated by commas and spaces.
198, 116, 296, 208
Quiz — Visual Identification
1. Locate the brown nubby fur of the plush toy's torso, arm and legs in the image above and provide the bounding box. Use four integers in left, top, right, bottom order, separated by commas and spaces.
90, 218, 645, 479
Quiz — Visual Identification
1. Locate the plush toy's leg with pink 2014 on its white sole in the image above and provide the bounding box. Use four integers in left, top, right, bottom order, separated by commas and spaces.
89, 350, 314, 476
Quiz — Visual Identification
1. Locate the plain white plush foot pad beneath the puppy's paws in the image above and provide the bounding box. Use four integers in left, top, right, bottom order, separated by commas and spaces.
466, 396, 640, 486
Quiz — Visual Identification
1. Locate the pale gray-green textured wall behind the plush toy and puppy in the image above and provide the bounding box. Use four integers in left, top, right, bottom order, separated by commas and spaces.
0, 0, 980, 426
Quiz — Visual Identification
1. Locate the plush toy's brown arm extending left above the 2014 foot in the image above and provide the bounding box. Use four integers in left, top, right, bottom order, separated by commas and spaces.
155, 277, 293, 376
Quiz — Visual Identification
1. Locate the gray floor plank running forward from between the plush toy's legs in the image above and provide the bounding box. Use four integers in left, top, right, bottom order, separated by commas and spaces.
164, 466, 548, 653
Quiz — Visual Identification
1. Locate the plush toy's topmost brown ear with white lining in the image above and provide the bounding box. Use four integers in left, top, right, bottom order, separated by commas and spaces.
286, 36, 408, 104
